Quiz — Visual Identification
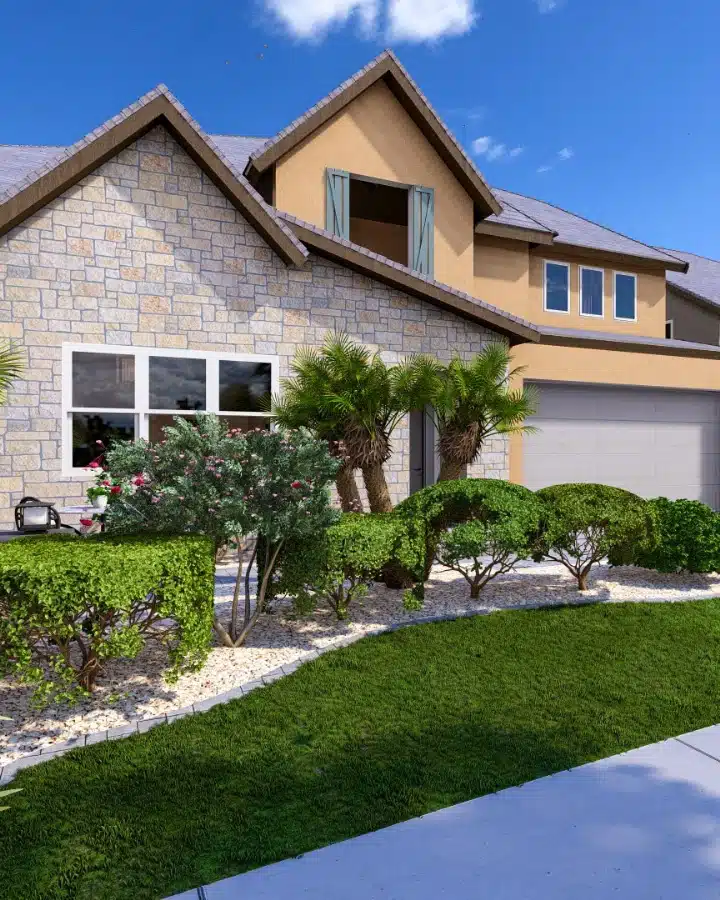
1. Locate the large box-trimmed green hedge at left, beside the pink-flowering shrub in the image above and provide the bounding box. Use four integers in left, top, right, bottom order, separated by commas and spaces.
0, 535, 214, 703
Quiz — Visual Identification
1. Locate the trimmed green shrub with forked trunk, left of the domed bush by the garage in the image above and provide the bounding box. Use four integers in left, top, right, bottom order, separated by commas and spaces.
435, 481, 541, 597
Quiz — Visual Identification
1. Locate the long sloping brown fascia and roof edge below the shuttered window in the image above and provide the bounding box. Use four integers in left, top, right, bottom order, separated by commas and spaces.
281, 213, 540, 345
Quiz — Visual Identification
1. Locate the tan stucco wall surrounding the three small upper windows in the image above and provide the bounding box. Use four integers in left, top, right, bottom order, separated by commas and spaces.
524, 247, 665, 337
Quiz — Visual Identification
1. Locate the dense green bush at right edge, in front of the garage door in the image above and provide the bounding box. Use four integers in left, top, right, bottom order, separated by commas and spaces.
632, 497, 720, 573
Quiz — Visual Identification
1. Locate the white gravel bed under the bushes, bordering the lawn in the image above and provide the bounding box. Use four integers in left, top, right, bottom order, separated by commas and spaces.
0, 563, 720, 766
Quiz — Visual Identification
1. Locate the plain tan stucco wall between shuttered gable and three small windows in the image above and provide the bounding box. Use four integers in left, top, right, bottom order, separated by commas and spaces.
473, 235, 531, 318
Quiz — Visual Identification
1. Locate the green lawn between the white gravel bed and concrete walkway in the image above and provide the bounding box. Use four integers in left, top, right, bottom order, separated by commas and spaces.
0, 600, 720, 900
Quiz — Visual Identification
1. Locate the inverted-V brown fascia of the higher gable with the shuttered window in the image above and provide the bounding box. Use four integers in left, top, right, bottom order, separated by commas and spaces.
245, 50, 502, 216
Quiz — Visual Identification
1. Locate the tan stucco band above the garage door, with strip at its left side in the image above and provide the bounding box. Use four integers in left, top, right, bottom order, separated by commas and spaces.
510, 344, 720, 484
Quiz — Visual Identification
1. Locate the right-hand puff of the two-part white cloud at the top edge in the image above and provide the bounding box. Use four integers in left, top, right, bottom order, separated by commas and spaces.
387, 0, 476, 42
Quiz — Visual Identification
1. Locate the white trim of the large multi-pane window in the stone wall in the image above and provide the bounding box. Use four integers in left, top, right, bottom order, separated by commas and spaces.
61, 344, 280, 479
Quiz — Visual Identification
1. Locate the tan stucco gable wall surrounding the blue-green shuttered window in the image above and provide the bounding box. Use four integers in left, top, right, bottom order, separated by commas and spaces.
275, 82, 473, 293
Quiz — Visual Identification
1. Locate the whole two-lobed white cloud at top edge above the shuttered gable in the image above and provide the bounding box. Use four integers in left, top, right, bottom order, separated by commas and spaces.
262, 0, 476, 43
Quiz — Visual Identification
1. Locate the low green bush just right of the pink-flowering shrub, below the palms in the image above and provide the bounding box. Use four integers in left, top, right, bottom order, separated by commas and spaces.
275, 513, 406, 619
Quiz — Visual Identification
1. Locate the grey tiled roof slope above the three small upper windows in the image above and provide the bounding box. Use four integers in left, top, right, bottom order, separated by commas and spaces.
486, 188, 686, 272
